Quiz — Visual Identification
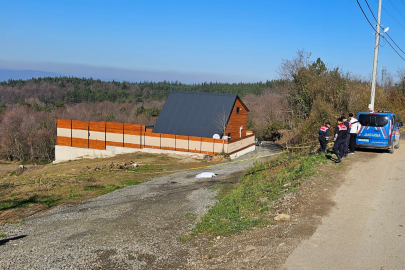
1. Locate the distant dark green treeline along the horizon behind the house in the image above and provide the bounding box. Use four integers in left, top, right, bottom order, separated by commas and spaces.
0, 77, 283, 104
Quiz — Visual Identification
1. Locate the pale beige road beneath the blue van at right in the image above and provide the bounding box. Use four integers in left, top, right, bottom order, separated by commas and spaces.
283, 147, 405, 269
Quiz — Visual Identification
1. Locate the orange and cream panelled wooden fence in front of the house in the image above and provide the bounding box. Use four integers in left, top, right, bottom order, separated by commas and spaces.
56, 119, 254, 155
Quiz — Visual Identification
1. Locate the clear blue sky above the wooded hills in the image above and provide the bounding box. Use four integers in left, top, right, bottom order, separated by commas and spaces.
0, 0, 405, 83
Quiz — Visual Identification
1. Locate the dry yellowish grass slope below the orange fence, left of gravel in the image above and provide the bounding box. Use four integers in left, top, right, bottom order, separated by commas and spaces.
0, 153, 205, 224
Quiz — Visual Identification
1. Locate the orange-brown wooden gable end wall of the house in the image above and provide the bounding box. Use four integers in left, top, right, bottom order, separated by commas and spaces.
224, 98, 248, 141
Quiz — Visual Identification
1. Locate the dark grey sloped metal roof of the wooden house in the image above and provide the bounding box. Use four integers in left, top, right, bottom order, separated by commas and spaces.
153, 91, 238, 138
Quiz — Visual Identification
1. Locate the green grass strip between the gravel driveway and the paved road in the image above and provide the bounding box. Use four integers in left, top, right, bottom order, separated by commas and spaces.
192, 153, 327, 236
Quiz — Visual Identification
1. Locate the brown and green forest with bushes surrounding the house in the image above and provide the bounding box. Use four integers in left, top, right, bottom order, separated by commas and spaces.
0, 51, 405, 161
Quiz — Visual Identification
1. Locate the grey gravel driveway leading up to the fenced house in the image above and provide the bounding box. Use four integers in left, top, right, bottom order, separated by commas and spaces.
0, 144, 278, 269
